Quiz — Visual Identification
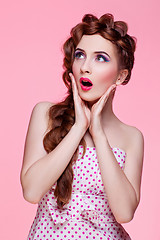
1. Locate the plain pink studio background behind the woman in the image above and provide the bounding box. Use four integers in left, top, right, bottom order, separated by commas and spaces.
0, 0, 160, 240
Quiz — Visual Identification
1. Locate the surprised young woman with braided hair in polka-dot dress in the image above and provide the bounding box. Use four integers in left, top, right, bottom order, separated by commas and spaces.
21, 14, 144, 240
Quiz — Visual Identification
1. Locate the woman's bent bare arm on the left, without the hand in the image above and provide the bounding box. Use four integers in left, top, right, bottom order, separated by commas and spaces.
20, 102, 86, 203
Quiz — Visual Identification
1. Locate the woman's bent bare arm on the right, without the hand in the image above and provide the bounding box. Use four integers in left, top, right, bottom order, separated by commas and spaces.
94, 129, 144, 223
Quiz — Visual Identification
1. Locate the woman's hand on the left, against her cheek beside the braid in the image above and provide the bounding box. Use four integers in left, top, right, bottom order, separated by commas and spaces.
69, 73, 90, 131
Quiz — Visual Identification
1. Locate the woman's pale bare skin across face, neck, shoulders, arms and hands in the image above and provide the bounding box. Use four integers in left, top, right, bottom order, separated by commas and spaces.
21, 35, 144, 223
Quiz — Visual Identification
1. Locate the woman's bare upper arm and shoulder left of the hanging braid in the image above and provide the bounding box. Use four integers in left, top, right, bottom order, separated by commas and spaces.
21, 102, 54, 177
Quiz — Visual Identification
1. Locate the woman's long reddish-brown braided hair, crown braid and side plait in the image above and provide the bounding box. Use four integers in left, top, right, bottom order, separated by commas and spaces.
43, 13, 136, 208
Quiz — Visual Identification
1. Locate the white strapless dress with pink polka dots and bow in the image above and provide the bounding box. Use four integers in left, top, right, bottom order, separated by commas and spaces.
28, 145, 131, 240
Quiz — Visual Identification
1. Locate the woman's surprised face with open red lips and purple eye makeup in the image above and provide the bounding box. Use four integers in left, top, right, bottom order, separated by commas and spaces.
72, 34, 119, 102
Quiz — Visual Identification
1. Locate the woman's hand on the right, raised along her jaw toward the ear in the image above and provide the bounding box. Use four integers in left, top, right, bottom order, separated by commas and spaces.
89, 84, 117, 138
